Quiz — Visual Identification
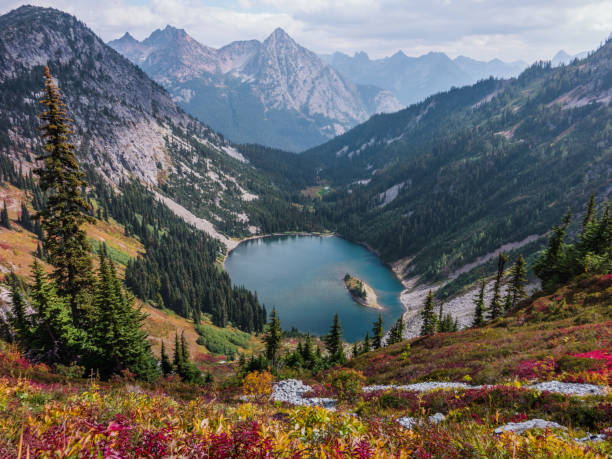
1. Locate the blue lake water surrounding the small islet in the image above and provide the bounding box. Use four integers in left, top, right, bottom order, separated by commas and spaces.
225, 236, 402, 341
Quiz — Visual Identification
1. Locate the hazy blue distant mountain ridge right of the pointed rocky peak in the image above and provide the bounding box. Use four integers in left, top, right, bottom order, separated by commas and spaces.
322, 51, 527, 106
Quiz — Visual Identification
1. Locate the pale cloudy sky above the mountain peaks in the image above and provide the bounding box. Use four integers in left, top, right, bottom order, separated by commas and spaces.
0, 0, 612, 62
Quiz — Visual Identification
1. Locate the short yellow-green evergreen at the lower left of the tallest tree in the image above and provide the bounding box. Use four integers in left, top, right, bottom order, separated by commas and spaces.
28, 259, 87, 364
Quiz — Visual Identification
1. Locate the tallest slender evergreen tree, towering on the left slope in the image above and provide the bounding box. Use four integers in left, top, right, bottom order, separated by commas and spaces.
36, 67, 93, 325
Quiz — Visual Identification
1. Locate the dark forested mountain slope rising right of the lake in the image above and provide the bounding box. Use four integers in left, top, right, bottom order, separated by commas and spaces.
303, 41, 612, 279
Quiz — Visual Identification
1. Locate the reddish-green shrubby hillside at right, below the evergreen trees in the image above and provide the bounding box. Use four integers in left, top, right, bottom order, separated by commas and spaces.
348, 274, 612, 384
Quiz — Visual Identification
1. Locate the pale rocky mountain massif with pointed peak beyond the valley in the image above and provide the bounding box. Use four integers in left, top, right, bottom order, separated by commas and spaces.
109, 26, 401, 151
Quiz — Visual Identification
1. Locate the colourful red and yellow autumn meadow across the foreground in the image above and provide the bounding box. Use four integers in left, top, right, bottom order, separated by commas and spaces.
0, 347, 612, 458
